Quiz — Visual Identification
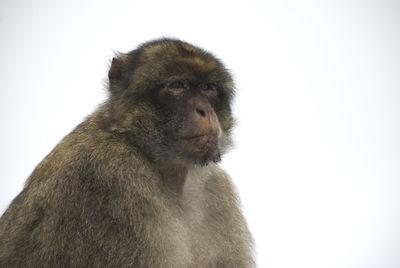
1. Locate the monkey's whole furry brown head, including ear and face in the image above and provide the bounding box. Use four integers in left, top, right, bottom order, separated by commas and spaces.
103, 39, 234, 165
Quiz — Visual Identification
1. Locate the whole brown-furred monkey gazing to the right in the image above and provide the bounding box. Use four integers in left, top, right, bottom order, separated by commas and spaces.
0, 38, 255, 268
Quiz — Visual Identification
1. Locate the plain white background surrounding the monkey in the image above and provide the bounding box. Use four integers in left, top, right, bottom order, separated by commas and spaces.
0, 0, 400, 268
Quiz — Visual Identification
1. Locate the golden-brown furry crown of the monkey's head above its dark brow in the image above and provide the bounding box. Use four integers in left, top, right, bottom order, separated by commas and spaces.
126, 39, 233, 95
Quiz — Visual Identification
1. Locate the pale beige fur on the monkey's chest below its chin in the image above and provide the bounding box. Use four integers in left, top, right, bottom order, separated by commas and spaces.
155, 164, 224, 267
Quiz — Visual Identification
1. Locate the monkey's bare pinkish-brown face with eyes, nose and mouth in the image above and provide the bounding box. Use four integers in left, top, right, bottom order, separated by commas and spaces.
157, 79, 222, 165
